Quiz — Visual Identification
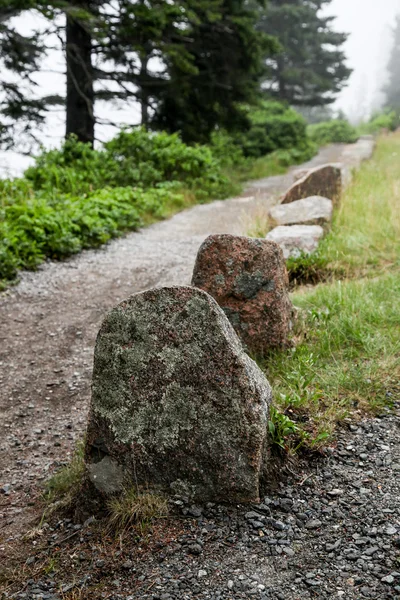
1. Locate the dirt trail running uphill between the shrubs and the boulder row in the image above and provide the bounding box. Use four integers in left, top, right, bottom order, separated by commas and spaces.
0, 145, 368, 548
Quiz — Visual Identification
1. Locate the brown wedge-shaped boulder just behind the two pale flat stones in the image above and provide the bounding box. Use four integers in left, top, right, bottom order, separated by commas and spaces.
281, 164, 342, 204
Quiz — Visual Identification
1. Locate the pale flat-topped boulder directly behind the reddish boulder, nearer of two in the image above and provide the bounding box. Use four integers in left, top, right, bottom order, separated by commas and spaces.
266, 225, 324, 259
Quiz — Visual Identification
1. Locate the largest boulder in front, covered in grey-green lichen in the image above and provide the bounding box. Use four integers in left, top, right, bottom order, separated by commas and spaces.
86, 287, 271, 502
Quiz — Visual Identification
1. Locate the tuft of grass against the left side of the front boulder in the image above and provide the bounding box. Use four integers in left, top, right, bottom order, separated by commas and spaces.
44, 441, 85, 506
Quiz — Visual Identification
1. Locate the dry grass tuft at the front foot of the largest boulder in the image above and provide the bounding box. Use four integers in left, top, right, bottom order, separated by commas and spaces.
107, 488, 168, 533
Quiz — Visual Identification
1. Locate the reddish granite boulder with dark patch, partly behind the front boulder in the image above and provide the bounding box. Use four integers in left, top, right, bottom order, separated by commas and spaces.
192, 234, 292, 354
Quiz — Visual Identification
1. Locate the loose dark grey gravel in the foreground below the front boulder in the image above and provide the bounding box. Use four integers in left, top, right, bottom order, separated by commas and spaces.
1, 412, 400, 600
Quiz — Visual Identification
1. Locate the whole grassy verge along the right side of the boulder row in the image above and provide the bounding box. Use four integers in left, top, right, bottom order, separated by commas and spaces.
263, 134, 400, 450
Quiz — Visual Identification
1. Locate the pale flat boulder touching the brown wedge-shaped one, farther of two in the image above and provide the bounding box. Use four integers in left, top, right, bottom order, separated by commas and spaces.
269, 196, 333, 227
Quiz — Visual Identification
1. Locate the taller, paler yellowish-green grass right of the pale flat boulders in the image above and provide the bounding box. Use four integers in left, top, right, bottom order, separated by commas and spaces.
320, 134, 400, 277
